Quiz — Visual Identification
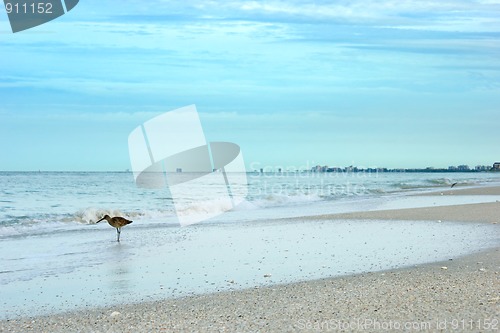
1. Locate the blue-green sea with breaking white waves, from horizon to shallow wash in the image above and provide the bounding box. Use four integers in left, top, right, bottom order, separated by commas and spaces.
0, 172, 500, 238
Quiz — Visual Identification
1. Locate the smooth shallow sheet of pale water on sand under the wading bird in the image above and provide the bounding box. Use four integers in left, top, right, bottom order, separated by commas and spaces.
0, 220, 500, 318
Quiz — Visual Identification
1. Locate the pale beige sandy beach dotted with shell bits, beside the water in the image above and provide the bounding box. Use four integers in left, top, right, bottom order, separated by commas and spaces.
0, 188, 500, 332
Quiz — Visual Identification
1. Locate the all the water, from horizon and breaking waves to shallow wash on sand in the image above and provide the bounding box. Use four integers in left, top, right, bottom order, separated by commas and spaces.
0, 172, 500, 318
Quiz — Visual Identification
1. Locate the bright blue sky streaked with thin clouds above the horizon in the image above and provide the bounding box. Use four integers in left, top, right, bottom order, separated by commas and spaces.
0, 0, 500, 171
